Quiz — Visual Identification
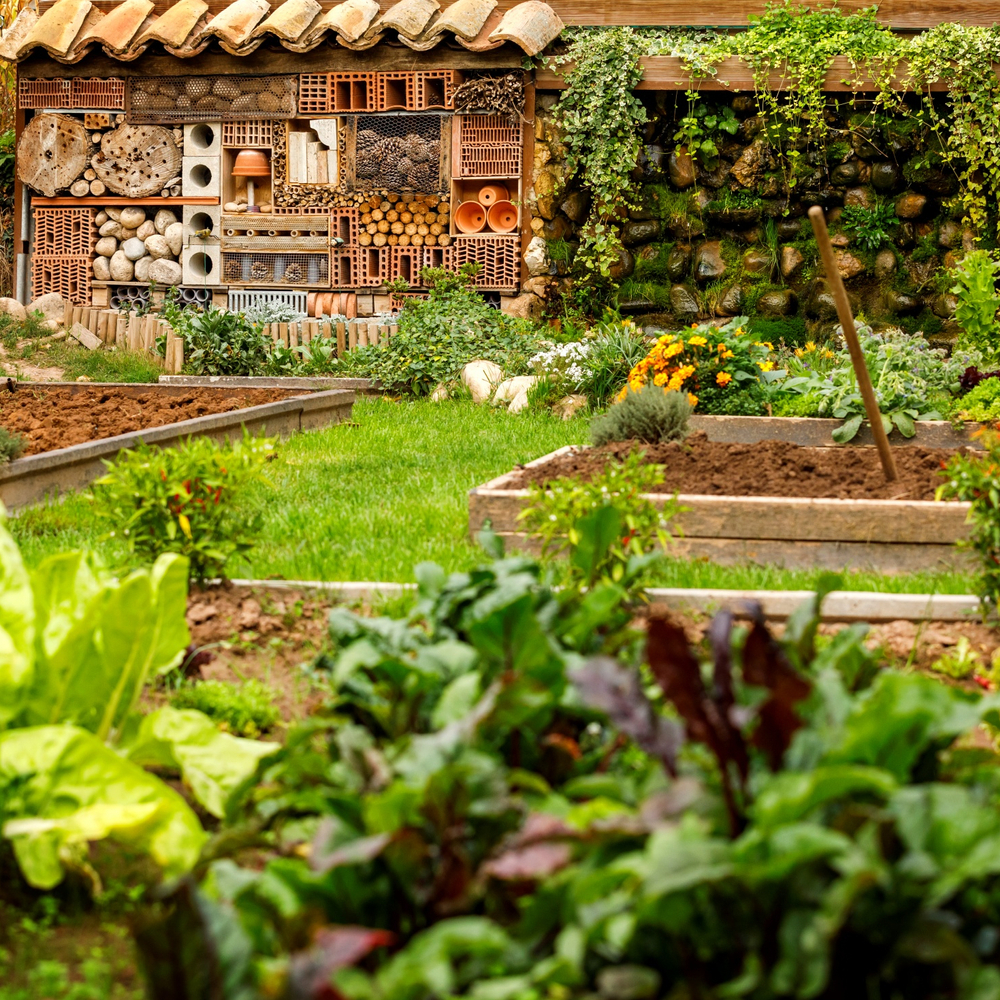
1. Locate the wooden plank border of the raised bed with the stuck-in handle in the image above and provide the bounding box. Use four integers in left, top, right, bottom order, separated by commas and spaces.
469, 444, 972, 573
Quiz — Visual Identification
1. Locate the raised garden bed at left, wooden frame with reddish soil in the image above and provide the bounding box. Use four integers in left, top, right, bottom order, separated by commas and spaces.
0, 382, 354, 508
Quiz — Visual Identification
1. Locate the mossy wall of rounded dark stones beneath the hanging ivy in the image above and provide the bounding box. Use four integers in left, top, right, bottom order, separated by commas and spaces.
521, 92, 973, 341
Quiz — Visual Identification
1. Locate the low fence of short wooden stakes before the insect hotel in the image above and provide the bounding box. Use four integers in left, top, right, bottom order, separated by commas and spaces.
63, 303, 399, 373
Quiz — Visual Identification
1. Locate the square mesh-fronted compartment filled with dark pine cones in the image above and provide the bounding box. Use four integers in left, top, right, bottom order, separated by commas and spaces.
355, 115, 441, 192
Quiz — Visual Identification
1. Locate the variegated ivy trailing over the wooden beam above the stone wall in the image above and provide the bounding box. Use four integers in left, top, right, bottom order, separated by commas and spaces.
552, 0, 1000, 285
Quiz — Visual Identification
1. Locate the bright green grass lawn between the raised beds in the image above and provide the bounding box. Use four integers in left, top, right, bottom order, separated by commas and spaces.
11, 399, 972, 593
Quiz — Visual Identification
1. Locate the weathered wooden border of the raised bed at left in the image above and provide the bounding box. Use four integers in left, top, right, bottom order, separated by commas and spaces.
0, 382, 354, 509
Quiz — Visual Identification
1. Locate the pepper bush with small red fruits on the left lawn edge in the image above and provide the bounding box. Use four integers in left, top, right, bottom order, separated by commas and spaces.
92, 432, 277, 582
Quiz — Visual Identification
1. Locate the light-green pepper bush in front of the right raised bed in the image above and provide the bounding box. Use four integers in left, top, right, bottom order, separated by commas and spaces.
518, 452, 680, 586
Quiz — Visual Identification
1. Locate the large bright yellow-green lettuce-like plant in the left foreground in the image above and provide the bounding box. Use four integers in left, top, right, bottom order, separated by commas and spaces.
0, 525, 273, 889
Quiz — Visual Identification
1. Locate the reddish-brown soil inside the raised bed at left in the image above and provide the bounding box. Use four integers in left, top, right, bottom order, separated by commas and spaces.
0, 386, 296, 455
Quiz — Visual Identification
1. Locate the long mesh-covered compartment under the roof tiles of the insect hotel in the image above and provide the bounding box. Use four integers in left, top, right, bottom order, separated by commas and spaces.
128, 76, 298, 122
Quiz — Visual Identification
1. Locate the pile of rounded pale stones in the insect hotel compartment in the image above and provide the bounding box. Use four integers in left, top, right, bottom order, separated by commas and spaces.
94, 206, 184, 285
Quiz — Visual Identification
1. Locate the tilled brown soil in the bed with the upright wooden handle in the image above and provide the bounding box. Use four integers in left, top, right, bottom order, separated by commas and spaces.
505, 432, 954, 500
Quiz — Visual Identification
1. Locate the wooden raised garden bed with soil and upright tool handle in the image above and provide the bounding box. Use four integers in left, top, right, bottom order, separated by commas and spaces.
469, 442, 972, 573
